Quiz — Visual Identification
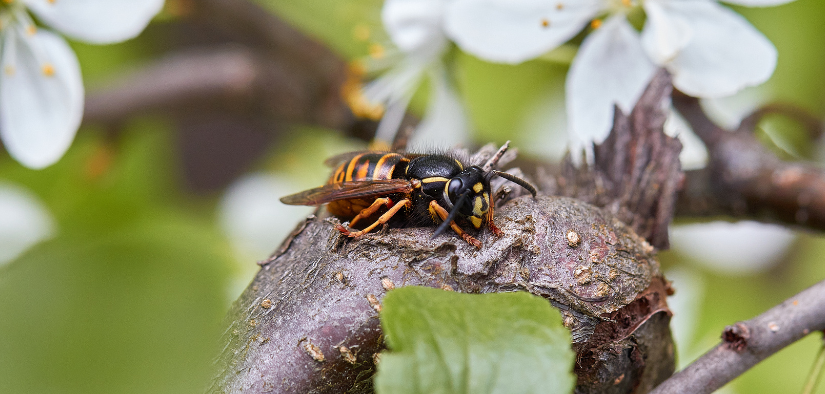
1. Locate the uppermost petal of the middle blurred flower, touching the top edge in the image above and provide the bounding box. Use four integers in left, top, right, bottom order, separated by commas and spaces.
381, 0, 447, 54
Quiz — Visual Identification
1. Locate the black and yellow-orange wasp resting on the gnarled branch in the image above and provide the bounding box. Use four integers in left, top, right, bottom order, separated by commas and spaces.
281, 141, 536, 248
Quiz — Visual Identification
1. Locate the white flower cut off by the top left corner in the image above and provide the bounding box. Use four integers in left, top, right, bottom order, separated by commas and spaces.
0, 0, 163, 168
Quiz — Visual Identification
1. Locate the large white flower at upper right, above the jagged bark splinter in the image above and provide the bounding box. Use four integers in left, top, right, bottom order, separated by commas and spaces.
445, 0, 793, 161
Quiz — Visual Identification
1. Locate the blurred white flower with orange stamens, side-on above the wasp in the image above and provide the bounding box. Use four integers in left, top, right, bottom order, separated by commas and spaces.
344, 0, 467, 144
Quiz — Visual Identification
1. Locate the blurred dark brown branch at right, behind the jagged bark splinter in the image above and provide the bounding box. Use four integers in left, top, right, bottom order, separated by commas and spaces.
673, 95, 825, 230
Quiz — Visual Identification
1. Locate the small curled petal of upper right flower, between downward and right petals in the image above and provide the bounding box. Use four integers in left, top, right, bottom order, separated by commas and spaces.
642, 0, 693, 64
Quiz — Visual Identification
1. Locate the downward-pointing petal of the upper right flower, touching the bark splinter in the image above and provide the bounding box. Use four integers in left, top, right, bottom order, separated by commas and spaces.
565, 15, 656, 159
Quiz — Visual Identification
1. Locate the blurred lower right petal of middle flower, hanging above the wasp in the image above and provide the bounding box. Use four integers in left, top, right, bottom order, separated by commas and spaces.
409, 67, 470, 151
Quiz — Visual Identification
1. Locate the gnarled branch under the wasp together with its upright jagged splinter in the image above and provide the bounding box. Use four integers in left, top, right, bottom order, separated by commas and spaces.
211, 72, 682, 393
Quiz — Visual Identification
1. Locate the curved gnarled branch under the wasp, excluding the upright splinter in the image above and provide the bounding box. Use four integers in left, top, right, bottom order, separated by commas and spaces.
212, 196, 673, 393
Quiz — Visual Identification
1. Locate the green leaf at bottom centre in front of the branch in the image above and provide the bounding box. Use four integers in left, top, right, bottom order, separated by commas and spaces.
375, 287, 576, 394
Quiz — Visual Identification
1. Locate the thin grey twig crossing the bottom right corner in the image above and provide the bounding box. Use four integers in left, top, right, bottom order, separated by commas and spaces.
652, 281, 825, 394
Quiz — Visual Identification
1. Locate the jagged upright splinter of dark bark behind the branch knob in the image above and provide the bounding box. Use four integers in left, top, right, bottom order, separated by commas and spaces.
542, 70, 684, 249
